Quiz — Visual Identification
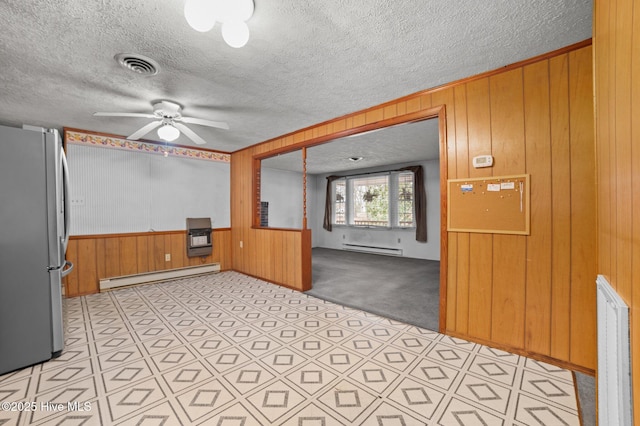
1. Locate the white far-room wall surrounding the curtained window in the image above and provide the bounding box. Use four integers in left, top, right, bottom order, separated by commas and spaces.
307, 160, 440, 260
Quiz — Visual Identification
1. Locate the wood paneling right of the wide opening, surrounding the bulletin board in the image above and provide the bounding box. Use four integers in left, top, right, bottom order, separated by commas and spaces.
444, 46, 596, 372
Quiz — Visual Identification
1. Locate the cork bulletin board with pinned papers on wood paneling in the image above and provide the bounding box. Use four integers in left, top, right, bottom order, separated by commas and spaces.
447, 174, 531, 235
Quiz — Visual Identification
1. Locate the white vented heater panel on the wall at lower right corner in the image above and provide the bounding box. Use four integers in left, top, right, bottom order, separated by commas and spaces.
596, 275, 633, 425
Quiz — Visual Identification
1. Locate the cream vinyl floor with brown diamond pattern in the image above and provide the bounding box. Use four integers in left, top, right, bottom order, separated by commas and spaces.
0, 272, 579, 426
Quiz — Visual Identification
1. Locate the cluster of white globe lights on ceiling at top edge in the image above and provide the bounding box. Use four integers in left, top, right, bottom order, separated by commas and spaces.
184, 0, 255, 48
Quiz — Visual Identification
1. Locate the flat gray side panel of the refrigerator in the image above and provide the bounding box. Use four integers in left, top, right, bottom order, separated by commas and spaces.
0, 127, 52, 374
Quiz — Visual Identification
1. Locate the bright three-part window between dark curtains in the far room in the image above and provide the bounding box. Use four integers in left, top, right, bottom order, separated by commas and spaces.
332, 172, 415, 228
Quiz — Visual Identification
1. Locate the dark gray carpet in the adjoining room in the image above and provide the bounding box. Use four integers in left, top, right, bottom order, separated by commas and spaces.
307, 248, 440, 331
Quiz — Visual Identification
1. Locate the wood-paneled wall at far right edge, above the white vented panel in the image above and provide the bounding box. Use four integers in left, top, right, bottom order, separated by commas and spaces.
593, 0, 640, 425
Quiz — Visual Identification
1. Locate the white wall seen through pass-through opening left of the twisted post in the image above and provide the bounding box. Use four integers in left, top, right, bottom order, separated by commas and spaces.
260, 167, 302, 229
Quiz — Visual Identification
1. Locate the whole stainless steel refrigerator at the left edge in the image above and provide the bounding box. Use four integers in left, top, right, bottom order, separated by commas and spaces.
0, 122, 73, 374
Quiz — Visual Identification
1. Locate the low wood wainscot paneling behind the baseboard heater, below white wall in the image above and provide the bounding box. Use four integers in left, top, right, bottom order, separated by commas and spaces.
64, 228, 232, 297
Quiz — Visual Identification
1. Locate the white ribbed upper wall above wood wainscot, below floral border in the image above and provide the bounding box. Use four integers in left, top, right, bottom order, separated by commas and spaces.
66, 144, 231, 235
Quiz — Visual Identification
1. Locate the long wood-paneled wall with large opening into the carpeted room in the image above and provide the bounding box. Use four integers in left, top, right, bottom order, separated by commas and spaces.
231, 40, 596, 372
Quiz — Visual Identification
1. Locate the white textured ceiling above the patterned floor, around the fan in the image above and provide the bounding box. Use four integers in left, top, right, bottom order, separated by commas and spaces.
0, 0, 592, 155
